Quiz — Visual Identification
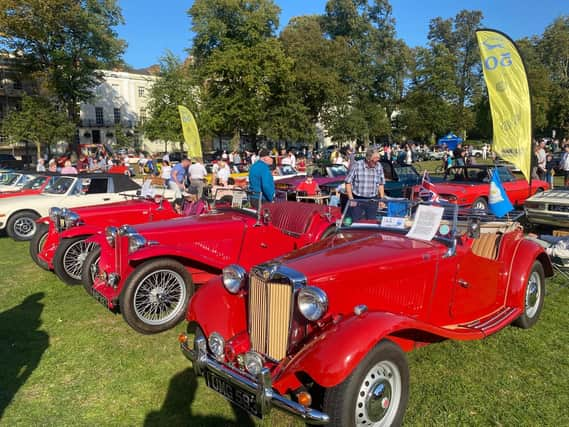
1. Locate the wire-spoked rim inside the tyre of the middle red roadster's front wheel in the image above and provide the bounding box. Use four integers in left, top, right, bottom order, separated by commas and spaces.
134, 269, 187, 325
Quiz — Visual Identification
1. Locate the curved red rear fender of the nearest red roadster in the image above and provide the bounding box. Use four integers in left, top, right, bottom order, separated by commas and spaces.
507, 239, 553, 309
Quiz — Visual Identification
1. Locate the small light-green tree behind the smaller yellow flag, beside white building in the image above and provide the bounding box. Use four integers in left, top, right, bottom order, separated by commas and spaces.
143, 52, 197, 151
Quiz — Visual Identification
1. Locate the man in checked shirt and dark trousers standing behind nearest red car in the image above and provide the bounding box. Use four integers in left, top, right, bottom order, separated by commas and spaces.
344, 148, 385, 221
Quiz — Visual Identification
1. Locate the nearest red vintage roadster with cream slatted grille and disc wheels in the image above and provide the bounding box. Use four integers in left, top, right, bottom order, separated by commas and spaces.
180, 200, 552, 426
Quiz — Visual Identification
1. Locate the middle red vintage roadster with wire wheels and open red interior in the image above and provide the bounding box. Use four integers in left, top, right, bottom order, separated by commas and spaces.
83, 189, 340, 334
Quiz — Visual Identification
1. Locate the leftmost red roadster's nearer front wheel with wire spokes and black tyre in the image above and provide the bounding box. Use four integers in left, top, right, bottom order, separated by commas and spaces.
53, 236, 97, 285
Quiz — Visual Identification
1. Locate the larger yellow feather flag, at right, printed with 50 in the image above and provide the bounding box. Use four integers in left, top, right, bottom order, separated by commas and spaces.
476, 29, 532, 181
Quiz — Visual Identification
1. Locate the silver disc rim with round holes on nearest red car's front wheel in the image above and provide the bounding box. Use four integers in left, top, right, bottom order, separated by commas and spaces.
355, 361, 402, 427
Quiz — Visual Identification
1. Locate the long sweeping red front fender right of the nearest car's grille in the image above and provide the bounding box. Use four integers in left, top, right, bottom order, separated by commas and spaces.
275, 312, 432, 389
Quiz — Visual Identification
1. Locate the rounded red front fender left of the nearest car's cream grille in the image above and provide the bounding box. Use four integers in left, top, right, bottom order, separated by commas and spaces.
186, 276, 247, 340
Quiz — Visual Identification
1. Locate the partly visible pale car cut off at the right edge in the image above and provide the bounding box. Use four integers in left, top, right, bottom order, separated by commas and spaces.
524, 188, 569, 228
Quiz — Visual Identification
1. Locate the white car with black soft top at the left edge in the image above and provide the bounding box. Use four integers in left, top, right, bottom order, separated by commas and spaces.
0, 173, 140, 240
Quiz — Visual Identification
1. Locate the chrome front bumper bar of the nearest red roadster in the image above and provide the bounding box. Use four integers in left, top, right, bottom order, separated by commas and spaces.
180, 337, 330, 425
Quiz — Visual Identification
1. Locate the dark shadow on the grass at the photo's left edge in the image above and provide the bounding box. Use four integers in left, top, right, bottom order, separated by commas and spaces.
0, 292, 49, 419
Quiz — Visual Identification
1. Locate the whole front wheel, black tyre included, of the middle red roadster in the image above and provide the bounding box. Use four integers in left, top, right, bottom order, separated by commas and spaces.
120, 258, 194, 334
